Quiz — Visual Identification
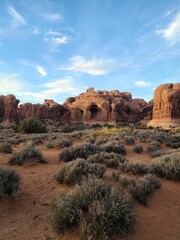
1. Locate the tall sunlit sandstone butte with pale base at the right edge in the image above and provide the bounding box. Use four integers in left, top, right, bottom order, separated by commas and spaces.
148, 83, 180, 128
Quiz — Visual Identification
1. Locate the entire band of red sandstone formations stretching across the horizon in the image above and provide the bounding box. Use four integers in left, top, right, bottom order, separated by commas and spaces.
0, 84, 180, 126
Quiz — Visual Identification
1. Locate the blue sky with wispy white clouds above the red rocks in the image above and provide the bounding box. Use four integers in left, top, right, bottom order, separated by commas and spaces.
0, 0, 180, 103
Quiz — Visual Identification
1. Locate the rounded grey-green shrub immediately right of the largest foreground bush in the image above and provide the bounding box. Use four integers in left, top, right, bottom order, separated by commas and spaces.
129, 174, 161, 206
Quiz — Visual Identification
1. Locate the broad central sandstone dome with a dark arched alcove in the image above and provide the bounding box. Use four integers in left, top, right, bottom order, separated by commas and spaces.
65, 88, 152, 124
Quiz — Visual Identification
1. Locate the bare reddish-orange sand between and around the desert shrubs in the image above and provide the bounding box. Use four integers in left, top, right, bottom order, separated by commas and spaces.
0, 143, 180, 240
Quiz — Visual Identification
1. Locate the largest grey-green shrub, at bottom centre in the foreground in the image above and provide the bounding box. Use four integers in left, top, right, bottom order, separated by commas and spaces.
51, 177, 135, 239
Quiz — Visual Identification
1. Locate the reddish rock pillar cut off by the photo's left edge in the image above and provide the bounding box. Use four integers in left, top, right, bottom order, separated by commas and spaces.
0, 94, 19, 127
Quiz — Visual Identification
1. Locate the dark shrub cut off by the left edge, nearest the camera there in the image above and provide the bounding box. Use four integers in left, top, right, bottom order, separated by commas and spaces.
0, 167, 21, 196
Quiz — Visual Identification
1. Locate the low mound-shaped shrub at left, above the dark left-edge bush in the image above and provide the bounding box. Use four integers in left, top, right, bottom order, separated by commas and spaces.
9, 144, 43, 165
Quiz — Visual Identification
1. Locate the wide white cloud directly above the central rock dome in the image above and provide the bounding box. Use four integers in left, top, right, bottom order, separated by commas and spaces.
60, 56, 115, 75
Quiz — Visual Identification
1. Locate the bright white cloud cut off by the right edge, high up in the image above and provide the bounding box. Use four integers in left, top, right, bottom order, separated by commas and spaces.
156, 13, 180, 44
